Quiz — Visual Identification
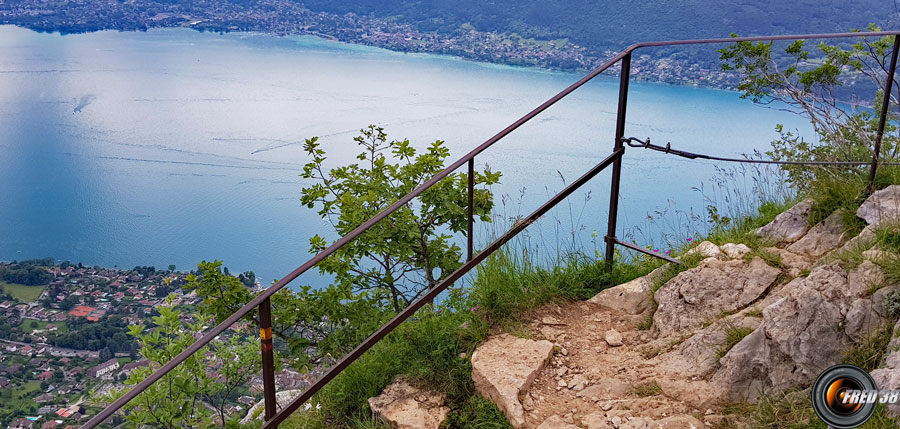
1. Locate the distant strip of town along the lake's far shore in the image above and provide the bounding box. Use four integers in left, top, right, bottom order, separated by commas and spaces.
0, 0, 738, 89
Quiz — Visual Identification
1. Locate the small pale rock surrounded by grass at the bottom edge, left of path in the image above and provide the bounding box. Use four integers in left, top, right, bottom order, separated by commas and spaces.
369, 377, 450, 429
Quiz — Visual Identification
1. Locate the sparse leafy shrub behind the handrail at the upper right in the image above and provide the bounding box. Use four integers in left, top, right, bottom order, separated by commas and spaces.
719, 25, 900, 191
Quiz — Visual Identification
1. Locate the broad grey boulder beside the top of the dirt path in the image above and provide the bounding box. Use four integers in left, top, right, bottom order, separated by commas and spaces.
653, 258, 781, 336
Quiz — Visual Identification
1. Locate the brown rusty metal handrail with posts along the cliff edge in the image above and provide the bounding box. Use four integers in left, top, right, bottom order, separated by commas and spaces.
82, 31, 900, 429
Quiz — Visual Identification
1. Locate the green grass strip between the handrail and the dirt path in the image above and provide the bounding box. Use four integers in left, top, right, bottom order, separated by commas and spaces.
282, 249, 654, 428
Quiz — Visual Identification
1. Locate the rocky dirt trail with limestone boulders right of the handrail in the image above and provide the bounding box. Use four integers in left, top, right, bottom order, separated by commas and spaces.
370, 186, 900, 429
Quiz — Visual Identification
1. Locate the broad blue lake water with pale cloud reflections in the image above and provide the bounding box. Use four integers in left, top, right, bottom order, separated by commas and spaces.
0, 26, 809, 284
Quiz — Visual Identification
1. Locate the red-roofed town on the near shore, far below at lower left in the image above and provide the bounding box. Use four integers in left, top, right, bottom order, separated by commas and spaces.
0, 258, 312, 429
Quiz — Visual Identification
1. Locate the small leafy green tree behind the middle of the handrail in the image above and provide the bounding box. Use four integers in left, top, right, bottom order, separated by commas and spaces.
301, 125, 500, 311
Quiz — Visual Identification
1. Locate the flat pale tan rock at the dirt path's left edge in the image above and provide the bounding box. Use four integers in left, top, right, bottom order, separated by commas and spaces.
472, 334, 553, 428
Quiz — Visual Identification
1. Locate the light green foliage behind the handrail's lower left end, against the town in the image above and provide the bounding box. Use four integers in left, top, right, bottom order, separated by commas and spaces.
108, 295, 260, 429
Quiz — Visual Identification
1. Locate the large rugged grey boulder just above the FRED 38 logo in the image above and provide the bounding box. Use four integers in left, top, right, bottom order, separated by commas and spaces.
711, 263, 864, 401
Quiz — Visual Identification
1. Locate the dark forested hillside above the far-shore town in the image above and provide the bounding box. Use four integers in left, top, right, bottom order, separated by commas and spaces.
302, 0, 900, 49
